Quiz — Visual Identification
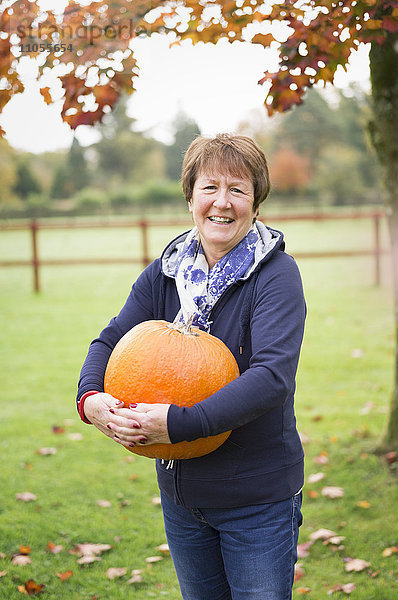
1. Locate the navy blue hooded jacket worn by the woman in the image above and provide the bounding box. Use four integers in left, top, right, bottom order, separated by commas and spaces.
77, 224, 306, 508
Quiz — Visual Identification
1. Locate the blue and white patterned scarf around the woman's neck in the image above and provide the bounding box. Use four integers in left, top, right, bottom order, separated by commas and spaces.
175, 224, 263, 331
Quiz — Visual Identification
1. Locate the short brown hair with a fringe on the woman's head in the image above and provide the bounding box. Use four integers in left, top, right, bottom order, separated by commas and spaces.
181, 133, 271, 210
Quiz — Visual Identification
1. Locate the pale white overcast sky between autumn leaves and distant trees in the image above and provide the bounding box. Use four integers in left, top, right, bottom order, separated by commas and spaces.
0, 20, 369, 152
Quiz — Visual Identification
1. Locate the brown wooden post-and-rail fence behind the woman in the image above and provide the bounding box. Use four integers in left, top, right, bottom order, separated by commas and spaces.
0, 210, 385, 292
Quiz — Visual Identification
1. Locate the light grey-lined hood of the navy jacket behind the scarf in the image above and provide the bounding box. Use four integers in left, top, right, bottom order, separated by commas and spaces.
161, 221, 285, 281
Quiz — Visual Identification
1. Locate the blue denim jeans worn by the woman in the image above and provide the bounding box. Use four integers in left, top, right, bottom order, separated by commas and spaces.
162, 493, 302, 600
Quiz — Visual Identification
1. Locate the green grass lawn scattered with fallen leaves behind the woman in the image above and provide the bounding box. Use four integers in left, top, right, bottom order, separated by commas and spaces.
0, 217, 398, 600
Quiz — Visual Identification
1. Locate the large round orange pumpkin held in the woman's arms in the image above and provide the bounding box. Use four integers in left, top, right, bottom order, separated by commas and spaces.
104, 321, 239, 460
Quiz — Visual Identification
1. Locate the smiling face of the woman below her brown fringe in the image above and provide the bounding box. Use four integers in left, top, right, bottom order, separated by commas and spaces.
189, 173, 258, 267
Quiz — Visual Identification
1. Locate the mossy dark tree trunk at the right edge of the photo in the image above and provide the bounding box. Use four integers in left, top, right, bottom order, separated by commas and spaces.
369, 33, 398, 450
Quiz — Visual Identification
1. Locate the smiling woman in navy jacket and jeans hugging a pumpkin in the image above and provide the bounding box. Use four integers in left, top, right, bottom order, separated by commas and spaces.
78, 135, 305, 600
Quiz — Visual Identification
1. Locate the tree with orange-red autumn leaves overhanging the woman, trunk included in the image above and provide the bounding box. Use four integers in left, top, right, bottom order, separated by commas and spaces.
0, 0, 398, 445
